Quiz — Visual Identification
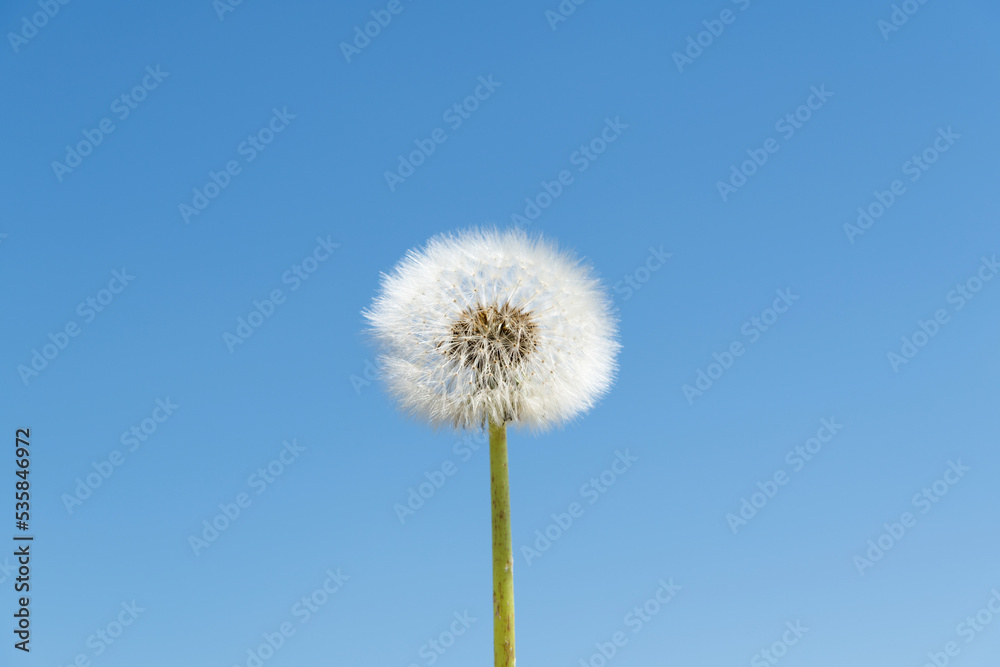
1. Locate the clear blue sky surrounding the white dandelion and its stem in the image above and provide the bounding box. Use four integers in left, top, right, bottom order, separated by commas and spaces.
0, 0, 1000, 667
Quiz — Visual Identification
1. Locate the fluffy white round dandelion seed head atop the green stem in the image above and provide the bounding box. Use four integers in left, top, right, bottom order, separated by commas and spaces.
364, 229, 620, 430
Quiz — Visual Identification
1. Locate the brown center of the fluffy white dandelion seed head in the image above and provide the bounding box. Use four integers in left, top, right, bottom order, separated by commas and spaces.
444, 303, 538, 374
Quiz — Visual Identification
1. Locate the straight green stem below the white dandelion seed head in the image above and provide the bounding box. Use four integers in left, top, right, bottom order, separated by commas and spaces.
490, 421, 514, 667
